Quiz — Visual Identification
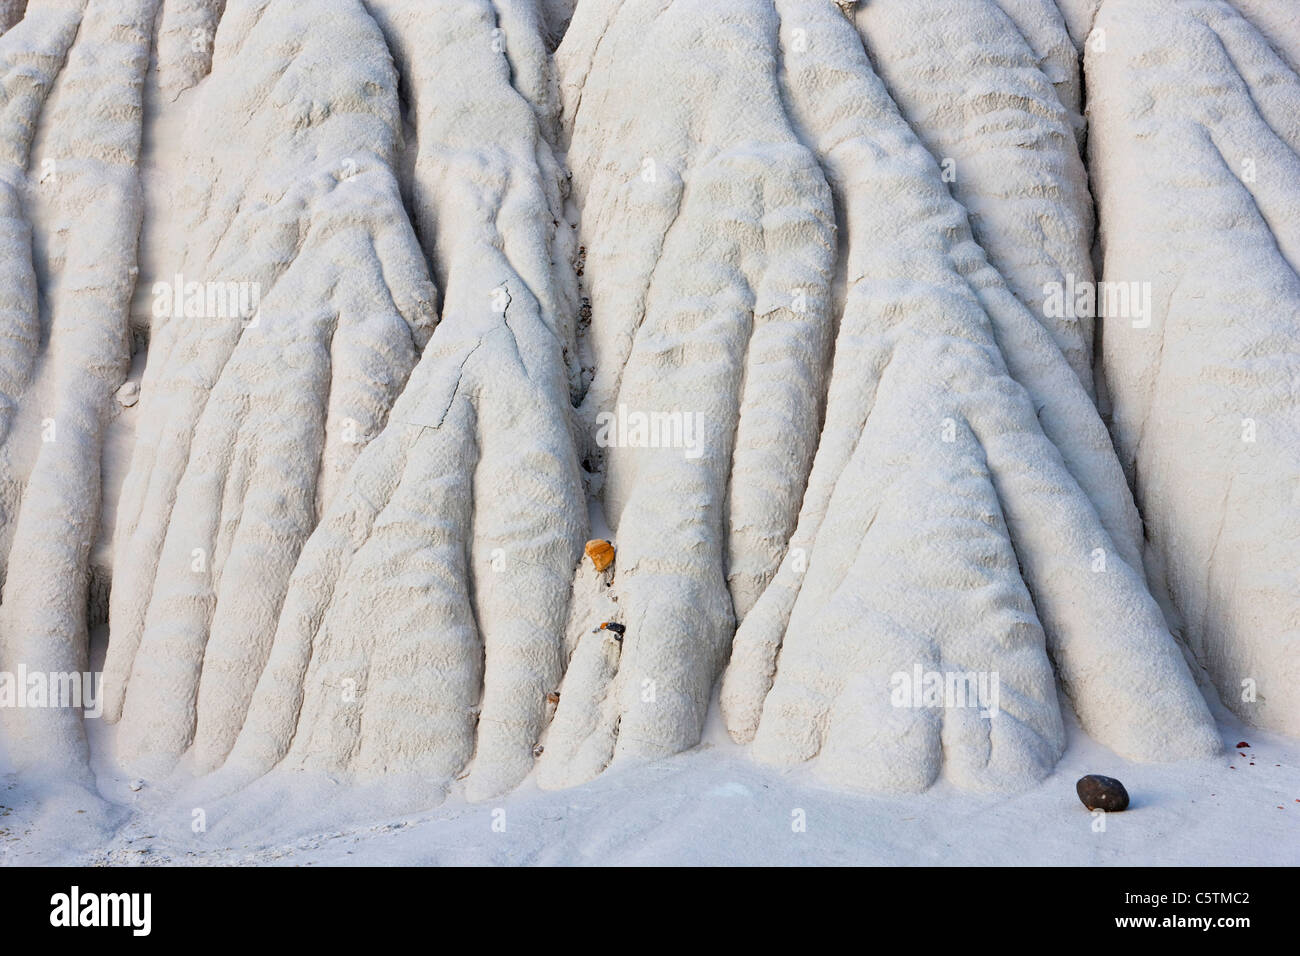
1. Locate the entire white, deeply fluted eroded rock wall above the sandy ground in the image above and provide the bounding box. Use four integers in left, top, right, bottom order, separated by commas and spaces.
0, 0, 1300, 803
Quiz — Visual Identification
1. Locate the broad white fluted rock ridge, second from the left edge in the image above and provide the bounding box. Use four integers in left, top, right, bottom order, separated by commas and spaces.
105, 3, 434, 780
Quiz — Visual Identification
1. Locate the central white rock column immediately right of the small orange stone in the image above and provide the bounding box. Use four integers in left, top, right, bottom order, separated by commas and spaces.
542, 0, 842, 784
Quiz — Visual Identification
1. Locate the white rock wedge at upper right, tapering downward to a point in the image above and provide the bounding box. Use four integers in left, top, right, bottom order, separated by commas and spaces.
855, 0, 1093, 394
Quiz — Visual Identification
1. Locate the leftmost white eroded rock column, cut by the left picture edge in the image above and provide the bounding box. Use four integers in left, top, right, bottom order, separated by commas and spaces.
0, 3, 143, 775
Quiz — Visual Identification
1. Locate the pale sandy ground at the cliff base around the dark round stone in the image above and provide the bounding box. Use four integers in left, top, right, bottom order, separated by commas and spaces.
0, 681, 1300, 866
